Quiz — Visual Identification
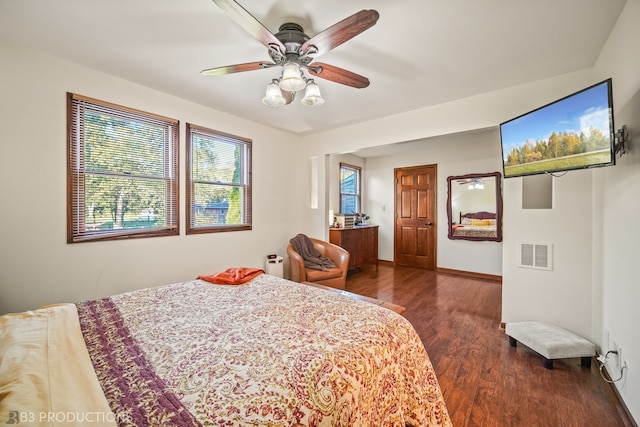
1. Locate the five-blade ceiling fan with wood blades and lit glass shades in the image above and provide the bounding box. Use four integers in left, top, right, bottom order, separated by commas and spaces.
200, 0, 380, 107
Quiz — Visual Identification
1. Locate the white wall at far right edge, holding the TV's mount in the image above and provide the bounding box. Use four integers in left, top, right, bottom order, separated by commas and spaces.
593, 0, 640, 421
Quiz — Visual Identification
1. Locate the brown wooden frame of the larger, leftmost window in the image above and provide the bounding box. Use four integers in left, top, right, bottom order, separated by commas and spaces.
67, 92, 180, 243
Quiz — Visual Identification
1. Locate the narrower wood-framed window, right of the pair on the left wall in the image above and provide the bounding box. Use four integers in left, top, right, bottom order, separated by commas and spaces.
187, 123, 251, 234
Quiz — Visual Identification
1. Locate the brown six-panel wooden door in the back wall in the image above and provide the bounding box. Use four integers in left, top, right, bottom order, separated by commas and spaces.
394, 165, 437, 270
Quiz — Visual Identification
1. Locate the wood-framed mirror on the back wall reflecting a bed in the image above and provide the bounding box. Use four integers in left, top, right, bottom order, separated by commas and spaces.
447, 172, 502, 242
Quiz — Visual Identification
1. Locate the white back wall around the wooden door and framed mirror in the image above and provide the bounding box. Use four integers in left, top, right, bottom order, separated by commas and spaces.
366, 127, 502, 276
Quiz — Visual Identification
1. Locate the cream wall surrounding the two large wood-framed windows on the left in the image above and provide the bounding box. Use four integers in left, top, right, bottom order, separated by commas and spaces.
0, 45, 307, 313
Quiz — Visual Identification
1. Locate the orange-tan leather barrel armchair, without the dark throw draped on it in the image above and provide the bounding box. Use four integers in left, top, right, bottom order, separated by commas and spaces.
287, 237, 349, 289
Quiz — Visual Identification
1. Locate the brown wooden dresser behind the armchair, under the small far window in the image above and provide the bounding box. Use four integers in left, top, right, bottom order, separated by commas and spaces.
329, 225, 378, 270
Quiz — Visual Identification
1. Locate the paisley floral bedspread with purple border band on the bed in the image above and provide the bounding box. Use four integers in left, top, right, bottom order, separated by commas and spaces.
78, 274, 451, 426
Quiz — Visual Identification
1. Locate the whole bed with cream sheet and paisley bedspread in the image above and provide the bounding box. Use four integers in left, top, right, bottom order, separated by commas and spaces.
0, 274, 451, 426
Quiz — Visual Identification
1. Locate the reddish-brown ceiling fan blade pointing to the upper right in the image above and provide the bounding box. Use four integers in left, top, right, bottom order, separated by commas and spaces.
302, 9, 380, 58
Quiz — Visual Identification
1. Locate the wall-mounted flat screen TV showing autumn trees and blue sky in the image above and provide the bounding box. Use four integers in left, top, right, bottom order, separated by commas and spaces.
500, 79, 615, 178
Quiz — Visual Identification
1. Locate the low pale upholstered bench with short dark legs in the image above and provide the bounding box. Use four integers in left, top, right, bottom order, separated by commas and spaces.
505, 322, 596, 369
